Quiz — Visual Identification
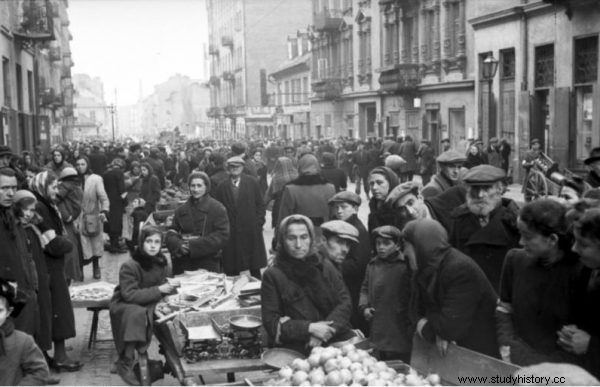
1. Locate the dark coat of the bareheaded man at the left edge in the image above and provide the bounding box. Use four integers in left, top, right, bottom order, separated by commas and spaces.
0, 206, 38, 335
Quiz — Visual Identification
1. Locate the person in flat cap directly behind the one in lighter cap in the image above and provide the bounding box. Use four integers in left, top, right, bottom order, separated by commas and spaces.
327, 191, 372, 335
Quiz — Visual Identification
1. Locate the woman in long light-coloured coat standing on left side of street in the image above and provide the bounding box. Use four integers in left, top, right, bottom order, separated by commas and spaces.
75, 156, 110, 279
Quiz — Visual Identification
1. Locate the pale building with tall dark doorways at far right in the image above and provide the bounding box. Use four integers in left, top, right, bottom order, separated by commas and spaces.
469, 0, 600, 179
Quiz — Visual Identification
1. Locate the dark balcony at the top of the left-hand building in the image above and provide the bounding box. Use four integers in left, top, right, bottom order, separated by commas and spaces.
13, 0, 54, 42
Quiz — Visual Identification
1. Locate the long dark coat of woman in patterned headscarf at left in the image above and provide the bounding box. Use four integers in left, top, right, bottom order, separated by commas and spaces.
35, 194, 75, 341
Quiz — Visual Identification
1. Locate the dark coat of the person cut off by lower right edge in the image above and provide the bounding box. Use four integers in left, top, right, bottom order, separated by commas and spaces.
570, 267, 600, 378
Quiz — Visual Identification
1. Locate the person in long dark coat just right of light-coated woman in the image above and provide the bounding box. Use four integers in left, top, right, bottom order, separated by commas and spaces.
102, 158, 126, 254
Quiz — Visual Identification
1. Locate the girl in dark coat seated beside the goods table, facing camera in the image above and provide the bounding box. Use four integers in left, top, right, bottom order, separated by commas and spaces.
110, 226, 175, 385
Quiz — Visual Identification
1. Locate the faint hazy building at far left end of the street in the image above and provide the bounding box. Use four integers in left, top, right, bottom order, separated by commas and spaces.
71, 74, 110, 140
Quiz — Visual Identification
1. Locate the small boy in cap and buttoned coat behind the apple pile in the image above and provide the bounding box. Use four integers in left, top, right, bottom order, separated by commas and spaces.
358, 226, 413, 364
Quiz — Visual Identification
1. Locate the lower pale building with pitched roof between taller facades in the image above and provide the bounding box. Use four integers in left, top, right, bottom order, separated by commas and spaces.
266, 30, 314, 139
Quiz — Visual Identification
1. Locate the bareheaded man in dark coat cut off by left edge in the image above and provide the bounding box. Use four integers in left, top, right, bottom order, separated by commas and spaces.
0, 167, 39, 335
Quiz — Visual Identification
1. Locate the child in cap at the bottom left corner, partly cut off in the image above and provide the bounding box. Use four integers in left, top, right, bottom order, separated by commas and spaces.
0, 279, 50, 386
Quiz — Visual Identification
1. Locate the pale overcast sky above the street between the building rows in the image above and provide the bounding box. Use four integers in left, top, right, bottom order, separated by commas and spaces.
68, 0, 208, 105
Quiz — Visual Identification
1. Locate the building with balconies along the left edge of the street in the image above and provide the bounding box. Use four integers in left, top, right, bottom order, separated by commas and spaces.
0, 0, 73, 151
